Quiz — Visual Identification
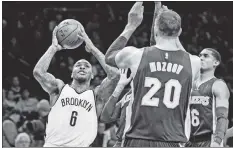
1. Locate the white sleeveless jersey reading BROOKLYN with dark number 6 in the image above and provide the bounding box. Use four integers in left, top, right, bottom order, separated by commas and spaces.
44, 84, 98, 147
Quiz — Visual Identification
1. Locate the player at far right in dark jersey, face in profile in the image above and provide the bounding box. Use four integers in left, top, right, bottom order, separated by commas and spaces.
186, 48, 229, 147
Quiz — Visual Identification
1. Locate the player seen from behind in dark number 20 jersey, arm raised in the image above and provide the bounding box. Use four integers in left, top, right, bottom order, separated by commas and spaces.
105, 2, 200, 147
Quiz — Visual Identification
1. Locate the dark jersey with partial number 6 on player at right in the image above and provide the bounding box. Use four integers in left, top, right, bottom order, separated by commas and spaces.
190, 78, 218, 139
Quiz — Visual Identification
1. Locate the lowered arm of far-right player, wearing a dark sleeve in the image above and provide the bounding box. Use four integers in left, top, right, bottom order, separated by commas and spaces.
211, 80, 230, 147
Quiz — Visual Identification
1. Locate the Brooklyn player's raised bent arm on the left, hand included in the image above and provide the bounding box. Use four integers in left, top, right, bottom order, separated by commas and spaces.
33, 27, 64, 95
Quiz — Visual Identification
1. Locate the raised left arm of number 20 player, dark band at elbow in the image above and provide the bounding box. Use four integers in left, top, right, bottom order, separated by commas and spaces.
105, 2, 144, 68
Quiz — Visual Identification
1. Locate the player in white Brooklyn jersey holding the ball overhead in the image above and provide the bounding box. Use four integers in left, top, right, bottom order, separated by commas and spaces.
33, 27, 119, 147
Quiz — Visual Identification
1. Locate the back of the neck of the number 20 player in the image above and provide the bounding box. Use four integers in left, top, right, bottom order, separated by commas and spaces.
155, 37, 180, 51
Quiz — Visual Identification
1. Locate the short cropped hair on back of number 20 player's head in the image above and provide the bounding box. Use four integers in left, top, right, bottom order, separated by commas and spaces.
156, 10, 181, 36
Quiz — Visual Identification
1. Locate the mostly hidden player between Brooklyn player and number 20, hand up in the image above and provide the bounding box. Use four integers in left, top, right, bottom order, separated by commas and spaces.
100, 69, 132, 147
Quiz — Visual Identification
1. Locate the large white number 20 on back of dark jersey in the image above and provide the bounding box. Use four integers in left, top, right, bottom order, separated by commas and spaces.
141, 77, 182, 109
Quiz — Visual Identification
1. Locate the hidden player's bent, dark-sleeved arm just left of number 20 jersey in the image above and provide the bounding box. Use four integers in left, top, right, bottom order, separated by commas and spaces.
100, 69, 132, 123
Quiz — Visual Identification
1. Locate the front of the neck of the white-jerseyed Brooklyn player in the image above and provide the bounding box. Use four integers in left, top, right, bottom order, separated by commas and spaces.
70, 80, 90, 93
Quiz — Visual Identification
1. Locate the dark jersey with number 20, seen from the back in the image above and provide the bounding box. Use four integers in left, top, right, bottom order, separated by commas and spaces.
125, 47, 192, 142
